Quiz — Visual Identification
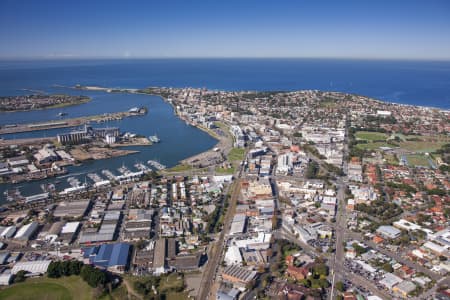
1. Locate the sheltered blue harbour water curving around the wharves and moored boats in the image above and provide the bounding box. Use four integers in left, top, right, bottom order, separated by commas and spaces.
0, 89, 216, 203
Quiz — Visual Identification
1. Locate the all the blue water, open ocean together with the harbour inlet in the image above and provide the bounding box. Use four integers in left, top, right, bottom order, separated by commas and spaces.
0, 59, 450, 203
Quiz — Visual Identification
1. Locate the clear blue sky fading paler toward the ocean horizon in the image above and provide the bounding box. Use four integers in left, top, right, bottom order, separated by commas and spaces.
0, 0, 450, 60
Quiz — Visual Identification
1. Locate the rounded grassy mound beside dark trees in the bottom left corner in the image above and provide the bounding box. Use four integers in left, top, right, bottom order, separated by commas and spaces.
0, 276, 93, 300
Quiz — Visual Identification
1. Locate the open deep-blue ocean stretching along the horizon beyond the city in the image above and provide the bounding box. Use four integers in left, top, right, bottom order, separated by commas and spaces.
0, 59, 450, 109
